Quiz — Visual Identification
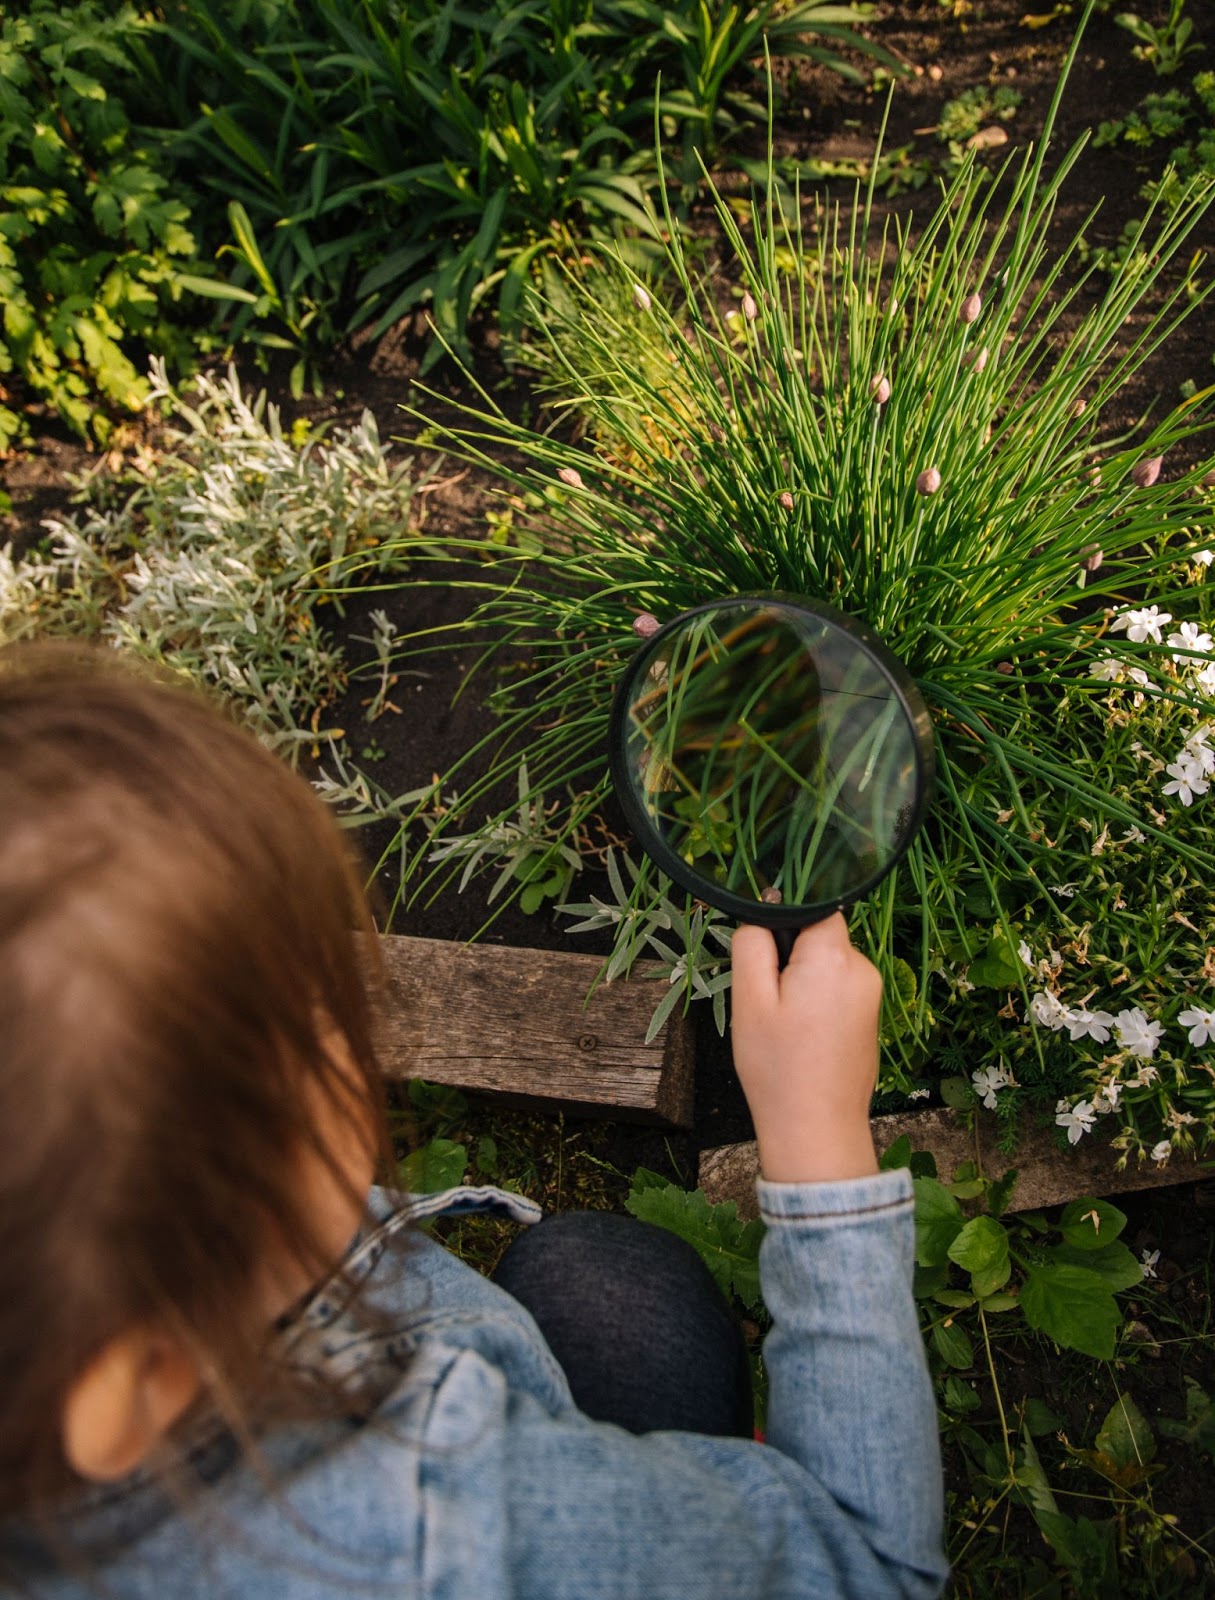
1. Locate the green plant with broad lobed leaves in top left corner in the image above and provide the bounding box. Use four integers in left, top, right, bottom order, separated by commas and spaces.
0, 0, 214, 450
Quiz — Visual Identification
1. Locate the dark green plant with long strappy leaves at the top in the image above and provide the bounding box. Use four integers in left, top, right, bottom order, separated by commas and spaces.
137, 0, 887, 366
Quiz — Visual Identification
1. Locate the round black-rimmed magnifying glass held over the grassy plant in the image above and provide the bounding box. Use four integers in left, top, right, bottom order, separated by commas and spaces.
608, 595, 935, 966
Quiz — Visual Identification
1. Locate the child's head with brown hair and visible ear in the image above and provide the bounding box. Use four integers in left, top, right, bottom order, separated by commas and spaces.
0, 646, 383, 1514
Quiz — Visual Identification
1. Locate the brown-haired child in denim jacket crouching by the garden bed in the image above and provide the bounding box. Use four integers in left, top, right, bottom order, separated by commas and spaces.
0, 646, 946, 1600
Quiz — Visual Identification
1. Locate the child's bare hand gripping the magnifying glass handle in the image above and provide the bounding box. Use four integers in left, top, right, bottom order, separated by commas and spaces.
732, 914, 882, 1182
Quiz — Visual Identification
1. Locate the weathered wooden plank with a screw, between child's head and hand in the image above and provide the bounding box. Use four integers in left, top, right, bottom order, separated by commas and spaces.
378, 934, 693, 1128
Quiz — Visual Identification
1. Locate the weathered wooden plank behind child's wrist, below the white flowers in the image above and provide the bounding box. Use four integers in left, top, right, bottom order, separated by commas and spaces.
700, 1109, 1209, 1218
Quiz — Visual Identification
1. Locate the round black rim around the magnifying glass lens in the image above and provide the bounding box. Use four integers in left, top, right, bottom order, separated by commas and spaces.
608, 592, 936, 928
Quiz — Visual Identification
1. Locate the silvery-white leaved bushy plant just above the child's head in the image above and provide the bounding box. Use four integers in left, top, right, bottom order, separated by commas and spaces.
0, 363, 416, 760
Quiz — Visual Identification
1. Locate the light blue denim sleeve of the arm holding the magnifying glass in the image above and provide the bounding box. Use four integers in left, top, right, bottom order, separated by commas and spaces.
493, 1173, 948, 1600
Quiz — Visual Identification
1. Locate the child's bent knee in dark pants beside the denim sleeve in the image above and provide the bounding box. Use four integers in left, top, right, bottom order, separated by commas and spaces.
493, 1211, 752, 1438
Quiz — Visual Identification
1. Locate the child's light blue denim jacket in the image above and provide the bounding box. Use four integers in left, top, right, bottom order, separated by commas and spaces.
0, 1171, 946, 1600
